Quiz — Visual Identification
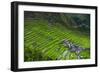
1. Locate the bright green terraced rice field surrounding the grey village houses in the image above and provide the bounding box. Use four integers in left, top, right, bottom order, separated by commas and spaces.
24, 20, 90, 61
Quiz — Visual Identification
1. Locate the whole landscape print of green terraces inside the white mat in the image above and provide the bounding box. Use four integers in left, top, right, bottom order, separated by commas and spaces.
24, 11, 91, 62
